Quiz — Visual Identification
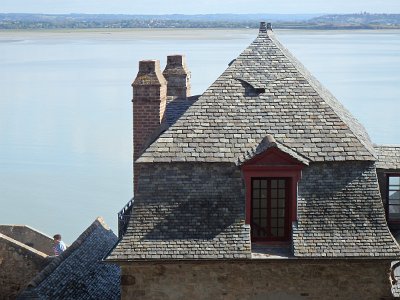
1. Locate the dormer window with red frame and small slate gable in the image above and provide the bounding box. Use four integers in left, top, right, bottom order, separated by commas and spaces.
242, 136, 308, 242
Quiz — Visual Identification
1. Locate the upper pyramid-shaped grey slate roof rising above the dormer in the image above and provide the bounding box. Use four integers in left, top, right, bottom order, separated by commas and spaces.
137, 24, 375, 163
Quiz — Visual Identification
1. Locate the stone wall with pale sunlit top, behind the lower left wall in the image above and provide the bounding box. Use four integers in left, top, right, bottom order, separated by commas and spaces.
0, 225, 54, 255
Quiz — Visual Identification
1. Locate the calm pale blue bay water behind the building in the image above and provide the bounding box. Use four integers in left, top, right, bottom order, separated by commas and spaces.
0, 30, 400, 243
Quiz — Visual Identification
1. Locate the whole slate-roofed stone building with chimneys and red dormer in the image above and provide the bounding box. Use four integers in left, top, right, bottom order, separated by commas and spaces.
107, 23, 400, 299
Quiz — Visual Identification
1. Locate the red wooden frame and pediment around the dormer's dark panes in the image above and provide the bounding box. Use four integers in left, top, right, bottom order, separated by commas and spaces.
242, 148, 304, 243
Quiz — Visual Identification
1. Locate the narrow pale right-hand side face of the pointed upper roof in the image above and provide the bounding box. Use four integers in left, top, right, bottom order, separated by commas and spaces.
268, 30, 377, 159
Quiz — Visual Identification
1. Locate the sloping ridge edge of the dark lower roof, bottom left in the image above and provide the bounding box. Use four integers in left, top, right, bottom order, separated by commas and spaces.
28, 217, 110, 288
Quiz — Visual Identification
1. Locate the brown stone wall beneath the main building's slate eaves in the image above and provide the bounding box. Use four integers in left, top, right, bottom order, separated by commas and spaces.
121, 259, 392, 300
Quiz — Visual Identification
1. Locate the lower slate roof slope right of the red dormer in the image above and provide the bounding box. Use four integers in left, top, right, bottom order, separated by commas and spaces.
293, 162, 400, 258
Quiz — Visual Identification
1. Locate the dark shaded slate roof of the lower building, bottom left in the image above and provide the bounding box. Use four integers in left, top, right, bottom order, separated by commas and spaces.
18, 218, 120, 300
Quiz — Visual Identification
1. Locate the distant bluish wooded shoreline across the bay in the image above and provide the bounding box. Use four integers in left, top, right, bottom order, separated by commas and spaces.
0, 13, 400, 29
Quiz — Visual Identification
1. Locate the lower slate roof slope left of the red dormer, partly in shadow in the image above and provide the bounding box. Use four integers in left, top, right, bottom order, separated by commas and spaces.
107, 163, 251, 261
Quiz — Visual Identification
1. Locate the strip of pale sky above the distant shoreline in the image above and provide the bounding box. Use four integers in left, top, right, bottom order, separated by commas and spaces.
0, 0, 400, 14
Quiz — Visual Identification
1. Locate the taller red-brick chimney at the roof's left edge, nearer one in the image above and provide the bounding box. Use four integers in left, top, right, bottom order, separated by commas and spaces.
132, 60, 167, 191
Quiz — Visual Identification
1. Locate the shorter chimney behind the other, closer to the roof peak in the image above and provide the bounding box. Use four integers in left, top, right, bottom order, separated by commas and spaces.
163, 55, 190, 99
